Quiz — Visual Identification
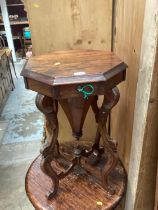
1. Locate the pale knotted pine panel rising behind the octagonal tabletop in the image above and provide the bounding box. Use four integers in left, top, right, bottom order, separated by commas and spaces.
25, 0, 112, 55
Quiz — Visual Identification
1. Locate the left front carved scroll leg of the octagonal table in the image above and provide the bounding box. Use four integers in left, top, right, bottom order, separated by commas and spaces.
36, 94, 59, 199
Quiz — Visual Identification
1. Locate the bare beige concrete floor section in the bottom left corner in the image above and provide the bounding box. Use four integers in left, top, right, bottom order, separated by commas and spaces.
0, 142, 39, 210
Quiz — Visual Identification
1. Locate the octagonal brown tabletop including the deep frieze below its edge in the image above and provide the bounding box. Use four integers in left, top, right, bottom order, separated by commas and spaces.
21, 50, 127, 99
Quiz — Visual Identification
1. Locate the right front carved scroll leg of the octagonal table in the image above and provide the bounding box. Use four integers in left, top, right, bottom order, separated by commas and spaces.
98, 87, 120, 194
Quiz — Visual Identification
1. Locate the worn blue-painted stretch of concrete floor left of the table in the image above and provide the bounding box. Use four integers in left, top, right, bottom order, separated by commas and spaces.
0, 60, 43, 144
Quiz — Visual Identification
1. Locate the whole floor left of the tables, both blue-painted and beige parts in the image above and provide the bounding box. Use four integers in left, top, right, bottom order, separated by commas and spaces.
0, 60, 43, 210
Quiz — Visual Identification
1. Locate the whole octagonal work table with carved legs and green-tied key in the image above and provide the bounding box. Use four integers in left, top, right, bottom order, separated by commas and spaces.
22, 50, 127, 208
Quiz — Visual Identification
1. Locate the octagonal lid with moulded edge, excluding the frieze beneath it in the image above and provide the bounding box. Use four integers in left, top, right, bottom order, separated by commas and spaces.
22, 50, 126, 85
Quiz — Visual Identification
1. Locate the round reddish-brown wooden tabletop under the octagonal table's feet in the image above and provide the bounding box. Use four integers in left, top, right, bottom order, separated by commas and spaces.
26, 142, 126, 210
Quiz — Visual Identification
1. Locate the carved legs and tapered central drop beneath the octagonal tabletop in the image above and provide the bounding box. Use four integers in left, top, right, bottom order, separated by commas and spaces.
31, 87, 126, 199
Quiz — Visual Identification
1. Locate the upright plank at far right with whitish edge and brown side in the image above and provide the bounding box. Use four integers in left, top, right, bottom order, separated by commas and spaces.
125, 0, 158, 210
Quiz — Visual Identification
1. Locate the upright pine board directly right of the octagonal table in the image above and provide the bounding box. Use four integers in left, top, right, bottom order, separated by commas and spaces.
111, 0, 145, 169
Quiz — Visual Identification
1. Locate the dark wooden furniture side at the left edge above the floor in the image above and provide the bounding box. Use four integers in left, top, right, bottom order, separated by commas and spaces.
0, 50, 14, 112
